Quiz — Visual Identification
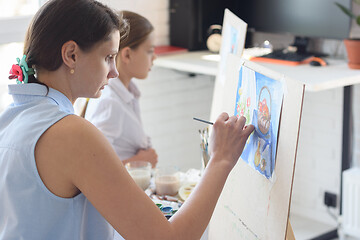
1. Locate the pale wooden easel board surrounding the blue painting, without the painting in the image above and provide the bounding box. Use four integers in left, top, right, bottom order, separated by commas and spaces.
209, 54, 305, 240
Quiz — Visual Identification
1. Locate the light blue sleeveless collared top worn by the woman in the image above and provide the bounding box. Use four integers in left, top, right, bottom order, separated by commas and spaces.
0, 83, 114, 240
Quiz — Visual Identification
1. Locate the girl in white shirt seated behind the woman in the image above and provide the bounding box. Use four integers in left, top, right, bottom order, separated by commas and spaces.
85, 11, 158, 168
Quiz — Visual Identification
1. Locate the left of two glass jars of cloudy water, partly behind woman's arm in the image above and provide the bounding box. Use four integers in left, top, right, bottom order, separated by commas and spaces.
125, 161, 151, 190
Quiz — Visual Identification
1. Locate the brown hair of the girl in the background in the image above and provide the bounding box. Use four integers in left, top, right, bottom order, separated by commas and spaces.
119, 11, 154, 50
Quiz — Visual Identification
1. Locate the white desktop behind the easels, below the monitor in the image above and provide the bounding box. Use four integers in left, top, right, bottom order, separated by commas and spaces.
154, 50, 360, 91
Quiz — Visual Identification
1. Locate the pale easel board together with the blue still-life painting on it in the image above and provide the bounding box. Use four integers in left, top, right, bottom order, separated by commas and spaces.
209, 54, 304, 240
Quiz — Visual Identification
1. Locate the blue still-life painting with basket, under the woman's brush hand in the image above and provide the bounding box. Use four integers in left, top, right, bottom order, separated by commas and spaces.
234, 66, 284, 180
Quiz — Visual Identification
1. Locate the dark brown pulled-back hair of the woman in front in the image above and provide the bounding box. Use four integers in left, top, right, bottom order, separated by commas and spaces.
24, 0, 124, 83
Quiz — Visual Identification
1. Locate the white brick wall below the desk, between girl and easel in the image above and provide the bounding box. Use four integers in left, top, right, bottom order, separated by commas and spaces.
136, 67, 215, 171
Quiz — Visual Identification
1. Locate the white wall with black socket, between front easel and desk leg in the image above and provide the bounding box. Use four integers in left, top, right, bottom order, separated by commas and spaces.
291, 88, 343, 225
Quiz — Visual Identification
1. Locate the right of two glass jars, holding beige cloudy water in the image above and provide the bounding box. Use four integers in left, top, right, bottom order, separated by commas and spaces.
155, 166, 180, 196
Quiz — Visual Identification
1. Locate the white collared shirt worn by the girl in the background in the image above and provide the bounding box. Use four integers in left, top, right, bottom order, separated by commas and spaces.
85, 78, 151, 160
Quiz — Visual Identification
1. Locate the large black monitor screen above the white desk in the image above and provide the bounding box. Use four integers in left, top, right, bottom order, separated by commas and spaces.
238, 0, 351, 39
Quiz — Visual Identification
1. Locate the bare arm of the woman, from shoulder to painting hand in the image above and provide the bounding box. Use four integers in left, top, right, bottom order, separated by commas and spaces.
35, 114, 253, 239
